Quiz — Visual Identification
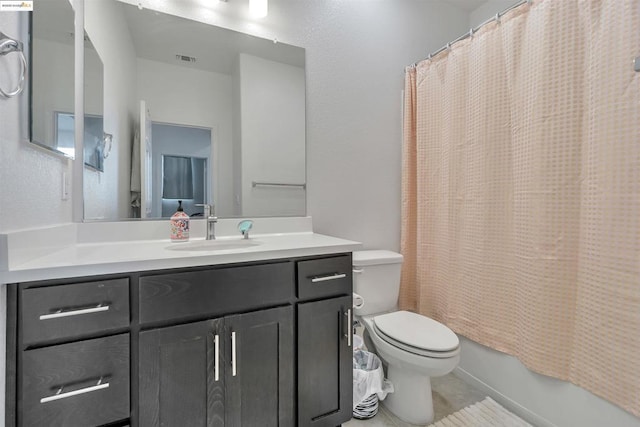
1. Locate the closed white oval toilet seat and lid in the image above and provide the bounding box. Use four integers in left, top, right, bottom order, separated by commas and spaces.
373, 311, 460, 359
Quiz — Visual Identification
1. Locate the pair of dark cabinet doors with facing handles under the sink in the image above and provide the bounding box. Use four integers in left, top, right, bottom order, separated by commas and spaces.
139, 306, 294, 427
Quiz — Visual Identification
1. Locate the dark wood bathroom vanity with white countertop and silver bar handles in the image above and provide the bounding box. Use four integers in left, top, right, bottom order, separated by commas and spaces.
5, 222, 357, 427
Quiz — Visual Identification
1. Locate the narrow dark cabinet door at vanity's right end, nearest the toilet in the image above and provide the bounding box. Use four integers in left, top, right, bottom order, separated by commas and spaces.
298, 296, 353, 427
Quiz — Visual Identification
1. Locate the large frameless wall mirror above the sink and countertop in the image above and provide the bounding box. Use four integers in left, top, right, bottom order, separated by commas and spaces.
84, 0, 306, 224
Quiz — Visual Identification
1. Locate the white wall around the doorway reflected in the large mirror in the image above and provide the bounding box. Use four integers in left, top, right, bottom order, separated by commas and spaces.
137, 58, 234, 217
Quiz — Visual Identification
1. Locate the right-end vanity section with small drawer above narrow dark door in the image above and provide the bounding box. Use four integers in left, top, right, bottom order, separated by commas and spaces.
296, 254, 353, 427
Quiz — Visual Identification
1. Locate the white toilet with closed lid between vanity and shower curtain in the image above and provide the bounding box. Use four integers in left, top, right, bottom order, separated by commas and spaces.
353, 251, 460, 425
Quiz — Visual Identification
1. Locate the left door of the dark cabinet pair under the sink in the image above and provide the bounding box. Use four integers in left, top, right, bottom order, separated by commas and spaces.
139, 319, 224, 427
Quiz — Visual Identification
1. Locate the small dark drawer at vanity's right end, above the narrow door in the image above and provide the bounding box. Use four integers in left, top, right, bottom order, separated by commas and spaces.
298, 254, 353, 299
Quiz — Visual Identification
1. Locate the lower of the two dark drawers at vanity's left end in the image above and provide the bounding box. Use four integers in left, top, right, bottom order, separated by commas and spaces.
20, 334, 130, 427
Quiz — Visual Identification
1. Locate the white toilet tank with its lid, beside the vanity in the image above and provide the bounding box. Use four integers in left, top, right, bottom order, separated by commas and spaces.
353, 250, 402, 316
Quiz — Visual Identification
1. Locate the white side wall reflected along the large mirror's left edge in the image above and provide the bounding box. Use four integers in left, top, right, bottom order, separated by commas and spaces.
83, 1, 137, 219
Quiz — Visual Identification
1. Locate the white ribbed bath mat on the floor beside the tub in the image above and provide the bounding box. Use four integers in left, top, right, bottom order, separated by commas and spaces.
430, 397, 533, 427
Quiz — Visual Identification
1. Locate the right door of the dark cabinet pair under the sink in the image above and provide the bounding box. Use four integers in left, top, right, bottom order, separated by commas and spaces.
225, 306, 295, 427
